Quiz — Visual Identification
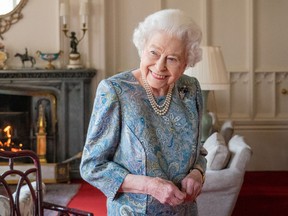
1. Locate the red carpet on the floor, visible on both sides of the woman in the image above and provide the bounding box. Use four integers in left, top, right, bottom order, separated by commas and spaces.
68, 171, 288, 216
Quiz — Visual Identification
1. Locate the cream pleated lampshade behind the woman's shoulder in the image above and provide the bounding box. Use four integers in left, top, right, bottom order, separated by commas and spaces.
185, 46, 229, 90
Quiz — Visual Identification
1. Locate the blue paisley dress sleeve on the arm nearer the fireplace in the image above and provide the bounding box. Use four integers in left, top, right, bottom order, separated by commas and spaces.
80, 80, 129, 199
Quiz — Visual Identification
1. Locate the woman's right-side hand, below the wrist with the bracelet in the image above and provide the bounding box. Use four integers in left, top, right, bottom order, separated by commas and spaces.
181, 169, 203, 200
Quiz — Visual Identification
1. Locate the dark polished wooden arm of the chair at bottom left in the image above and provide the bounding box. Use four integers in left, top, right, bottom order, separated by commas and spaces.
43, 202, 94, 216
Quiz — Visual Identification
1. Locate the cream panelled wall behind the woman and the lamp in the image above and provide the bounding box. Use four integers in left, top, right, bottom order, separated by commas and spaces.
105, 0, 288, 170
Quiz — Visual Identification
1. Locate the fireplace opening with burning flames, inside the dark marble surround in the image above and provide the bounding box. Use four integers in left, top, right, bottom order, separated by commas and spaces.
0, 92, 57, 159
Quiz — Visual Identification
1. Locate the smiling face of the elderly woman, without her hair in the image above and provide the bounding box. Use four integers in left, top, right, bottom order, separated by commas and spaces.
140, 32, 186, 91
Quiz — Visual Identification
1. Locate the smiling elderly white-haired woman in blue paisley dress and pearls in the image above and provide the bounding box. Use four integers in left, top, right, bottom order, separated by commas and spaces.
80, 9, 206, 216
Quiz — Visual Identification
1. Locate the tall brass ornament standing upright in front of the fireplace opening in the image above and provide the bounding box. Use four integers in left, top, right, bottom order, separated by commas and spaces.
36, 104, 47, 163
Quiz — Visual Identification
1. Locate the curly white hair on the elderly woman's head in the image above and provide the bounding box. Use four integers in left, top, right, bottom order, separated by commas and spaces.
133, 9, 202, 66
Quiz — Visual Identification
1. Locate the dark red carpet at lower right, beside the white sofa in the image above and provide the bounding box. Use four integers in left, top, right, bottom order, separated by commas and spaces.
232, 171, 288, 216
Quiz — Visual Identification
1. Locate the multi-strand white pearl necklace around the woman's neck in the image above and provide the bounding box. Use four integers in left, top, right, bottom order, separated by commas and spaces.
142, 76, 174, 116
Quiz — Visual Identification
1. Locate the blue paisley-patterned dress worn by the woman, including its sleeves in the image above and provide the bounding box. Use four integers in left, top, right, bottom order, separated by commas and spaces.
80, 71, 206, 216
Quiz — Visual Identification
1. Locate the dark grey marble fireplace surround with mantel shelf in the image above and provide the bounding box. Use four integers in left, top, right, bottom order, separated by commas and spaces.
0, 69, 96, 175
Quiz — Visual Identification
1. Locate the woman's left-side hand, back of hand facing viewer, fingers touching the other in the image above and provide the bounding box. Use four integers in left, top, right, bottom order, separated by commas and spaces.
146, 177, 186, 206
